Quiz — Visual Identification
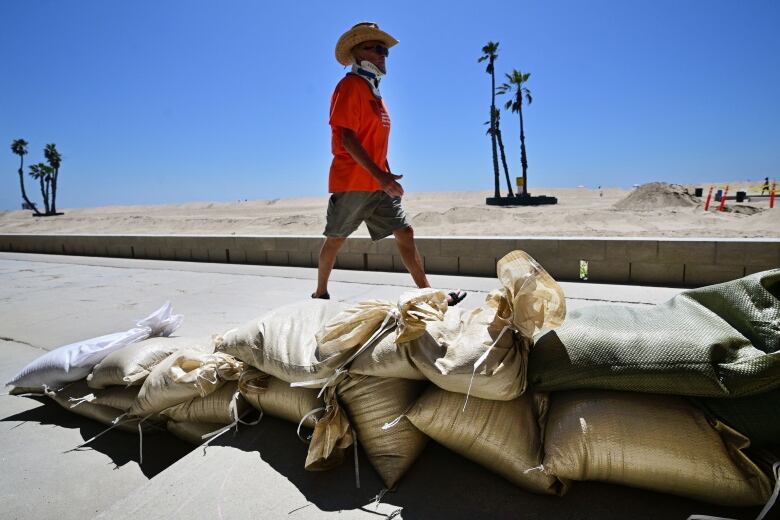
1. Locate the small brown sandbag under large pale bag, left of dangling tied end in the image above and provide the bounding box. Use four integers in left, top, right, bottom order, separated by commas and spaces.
238, 368, 324, 428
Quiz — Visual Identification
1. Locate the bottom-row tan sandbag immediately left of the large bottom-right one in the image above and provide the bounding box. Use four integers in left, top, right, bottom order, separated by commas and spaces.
406, 386, 563, 494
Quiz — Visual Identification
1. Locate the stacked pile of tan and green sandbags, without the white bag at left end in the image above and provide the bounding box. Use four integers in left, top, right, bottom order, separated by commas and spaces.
7, 251, 780, 505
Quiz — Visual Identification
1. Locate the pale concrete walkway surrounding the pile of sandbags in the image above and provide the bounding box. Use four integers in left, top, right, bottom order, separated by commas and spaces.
0, 253, 756, 520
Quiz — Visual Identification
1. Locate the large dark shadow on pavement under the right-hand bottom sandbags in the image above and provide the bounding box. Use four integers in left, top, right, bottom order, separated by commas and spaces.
207, 417, 760, 520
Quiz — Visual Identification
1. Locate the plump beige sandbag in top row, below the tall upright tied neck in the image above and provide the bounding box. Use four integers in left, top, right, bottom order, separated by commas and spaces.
409, 306, 530, 401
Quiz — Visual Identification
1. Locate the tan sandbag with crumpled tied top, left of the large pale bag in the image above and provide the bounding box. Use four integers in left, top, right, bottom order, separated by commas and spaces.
129, 350, 244, 417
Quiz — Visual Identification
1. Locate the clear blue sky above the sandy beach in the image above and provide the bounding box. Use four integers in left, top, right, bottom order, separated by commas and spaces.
0, 0, 780, 209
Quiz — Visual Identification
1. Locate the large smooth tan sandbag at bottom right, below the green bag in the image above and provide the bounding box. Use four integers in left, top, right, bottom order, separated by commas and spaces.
544, 390, 772, 506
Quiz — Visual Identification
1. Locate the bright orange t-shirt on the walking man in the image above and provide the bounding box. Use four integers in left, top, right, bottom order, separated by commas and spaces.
328, 73, 390, 193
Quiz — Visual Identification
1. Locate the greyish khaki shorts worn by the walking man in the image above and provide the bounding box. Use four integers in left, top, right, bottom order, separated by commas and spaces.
323, 191, 410, 240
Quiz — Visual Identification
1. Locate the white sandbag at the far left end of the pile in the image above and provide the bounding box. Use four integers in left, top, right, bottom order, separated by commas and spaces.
6, 303, 183, 389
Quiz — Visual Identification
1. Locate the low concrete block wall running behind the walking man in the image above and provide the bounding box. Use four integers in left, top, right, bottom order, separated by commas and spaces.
0, 234, 780, 287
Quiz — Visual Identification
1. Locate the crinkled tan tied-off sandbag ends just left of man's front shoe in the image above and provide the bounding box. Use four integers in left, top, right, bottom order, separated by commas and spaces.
317, 288, 447, 356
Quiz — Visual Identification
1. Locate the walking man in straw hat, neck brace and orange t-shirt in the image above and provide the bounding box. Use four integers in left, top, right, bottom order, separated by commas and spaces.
311, 22, 466, 305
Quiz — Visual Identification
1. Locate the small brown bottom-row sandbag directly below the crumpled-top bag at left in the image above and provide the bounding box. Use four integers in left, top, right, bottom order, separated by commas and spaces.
160, 381, 249, 424
